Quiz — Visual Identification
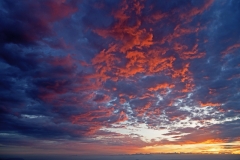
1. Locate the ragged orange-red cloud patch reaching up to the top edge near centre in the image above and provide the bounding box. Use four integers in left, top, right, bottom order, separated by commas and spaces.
94, 1, 153, 53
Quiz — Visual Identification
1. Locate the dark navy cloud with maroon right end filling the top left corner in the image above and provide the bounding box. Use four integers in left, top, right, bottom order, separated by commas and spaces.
1, 1, 77, 44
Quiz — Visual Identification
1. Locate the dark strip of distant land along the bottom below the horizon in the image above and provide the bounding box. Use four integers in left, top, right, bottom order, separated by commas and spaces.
0, 154, 240, 160
